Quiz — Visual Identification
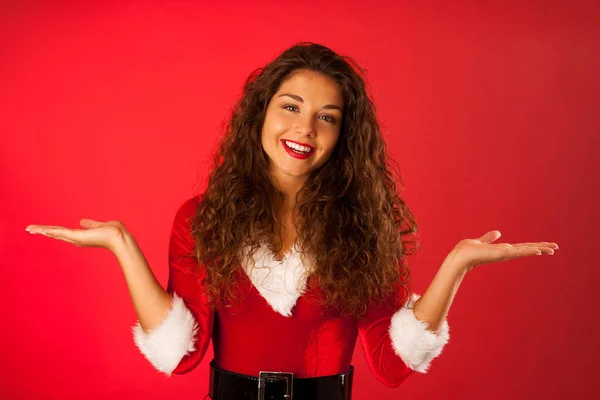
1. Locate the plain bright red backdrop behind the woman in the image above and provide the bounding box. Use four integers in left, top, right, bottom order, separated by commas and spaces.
0, 0, 600, 400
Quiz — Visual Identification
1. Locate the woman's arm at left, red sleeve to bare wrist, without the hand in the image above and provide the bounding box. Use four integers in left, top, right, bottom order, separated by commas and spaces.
113, 225, 213, 375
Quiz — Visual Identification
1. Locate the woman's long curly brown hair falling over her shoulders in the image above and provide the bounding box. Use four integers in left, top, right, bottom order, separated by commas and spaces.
192, 42, 418, 316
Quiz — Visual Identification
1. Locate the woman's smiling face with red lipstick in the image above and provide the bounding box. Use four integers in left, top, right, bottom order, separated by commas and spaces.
261, 70, 344, 186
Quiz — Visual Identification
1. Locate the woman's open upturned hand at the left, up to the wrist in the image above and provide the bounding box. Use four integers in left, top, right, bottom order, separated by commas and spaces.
25, 219, 127, 252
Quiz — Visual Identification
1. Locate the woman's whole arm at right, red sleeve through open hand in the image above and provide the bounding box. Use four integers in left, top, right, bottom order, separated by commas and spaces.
358, 231, 558, 387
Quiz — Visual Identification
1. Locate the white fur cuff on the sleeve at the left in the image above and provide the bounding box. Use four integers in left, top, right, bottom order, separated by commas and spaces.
132, 293, 198, 375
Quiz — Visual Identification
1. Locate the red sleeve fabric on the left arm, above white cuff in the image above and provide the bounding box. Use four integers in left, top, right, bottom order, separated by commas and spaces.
167, 197, 214, 374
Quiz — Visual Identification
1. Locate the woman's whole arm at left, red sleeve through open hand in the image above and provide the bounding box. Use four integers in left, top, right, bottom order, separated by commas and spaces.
26, 196, 214, 375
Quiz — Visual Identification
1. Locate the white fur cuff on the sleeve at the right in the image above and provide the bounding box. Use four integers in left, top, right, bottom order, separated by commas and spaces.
389, 294, 450, 372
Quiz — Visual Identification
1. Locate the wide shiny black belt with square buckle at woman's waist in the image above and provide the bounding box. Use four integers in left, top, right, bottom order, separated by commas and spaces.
209, 360, 354, 400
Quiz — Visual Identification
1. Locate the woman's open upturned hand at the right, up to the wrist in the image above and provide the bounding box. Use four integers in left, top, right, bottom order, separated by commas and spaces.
450, 230, 558, 272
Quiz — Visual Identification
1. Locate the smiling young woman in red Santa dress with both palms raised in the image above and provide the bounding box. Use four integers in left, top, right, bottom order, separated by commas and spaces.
27, 43, 558, 400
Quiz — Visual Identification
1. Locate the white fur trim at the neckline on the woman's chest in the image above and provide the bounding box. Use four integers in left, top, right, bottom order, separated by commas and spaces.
242, 244, 307, 317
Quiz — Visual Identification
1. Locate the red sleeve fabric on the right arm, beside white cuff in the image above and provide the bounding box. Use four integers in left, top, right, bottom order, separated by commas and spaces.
358, 293, 413, 387
